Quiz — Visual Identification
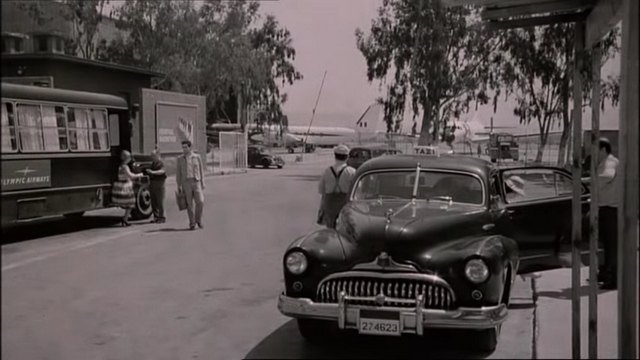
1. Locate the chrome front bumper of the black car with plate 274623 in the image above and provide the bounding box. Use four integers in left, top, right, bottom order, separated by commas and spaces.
278, 294, 507, 335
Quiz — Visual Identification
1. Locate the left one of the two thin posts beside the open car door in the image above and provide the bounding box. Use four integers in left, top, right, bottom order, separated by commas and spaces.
571, 22, 584, 359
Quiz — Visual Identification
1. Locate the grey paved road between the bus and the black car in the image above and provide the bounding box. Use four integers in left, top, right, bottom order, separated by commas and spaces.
2, 161, 534, 360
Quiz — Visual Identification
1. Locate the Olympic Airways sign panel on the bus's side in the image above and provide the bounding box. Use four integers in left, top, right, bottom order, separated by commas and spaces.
2, 160, 51, 192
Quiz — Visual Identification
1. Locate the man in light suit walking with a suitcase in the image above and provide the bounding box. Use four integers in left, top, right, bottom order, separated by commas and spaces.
176, 140, 205, 230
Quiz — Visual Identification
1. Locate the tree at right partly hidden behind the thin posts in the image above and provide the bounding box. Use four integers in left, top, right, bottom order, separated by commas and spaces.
498, 24, 618, 166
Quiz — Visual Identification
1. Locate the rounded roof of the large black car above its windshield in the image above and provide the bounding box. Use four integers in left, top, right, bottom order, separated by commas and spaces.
358, 154, 495, 177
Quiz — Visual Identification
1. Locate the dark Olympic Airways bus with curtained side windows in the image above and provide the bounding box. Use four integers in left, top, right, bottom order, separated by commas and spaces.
1, 83, 152, 228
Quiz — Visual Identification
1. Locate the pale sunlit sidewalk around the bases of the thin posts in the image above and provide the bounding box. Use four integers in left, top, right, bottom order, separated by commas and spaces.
534, 267, 618, 359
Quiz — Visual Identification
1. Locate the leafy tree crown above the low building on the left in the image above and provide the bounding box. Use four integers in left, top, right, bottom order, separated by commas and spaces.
95, 0, 302, 128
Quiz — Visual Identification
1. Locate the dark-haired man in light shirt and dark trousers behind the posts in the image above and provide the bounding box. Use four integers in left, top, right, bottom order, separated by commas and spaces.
582, 137, 620, 289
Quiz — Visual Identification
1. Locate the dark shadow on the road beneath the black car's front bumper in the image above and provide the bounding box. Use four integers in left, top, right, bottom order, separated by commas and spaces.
245, 320, 490, 359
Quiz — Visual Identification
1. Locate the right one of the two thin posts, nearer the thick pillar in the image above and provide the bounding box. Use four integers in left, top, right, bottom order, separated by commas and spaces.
589, 43, 602, 359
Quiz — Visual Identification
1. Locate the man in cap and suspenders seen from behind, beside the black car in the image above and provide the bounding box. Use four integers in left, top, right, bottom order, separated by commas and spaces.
318, 145, 356, 229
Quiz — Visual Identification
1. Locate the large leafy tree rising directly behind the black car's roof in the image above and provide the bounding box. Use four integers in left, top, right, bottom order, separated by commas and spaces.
356, 0, 497, 144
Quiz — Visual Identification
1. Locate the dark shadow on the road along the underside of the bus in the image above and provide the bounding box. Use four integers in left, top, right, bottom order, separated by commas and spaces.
2, 216, 121, 244
